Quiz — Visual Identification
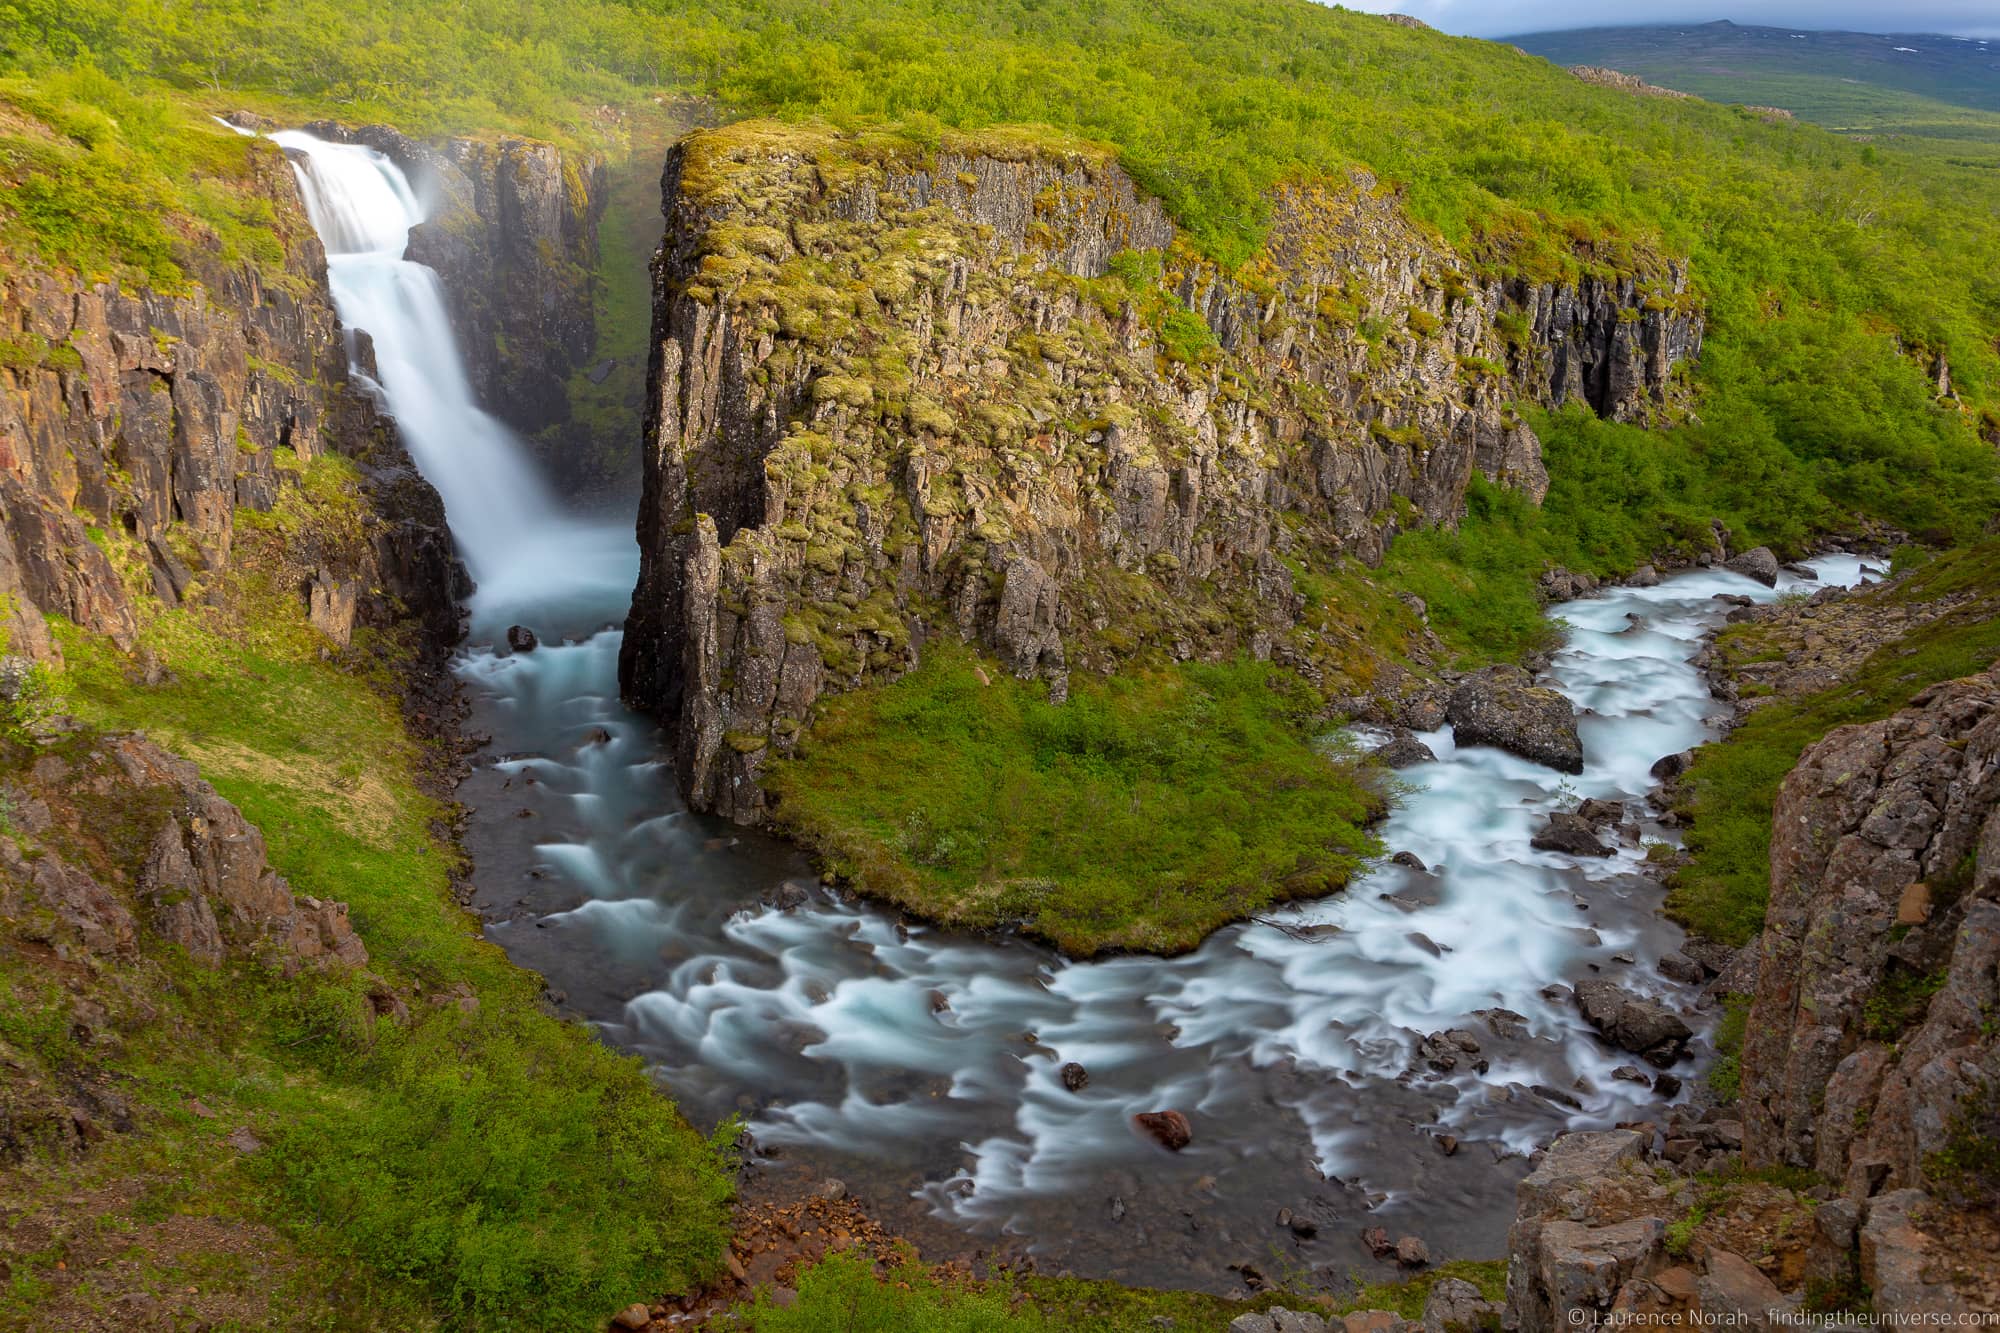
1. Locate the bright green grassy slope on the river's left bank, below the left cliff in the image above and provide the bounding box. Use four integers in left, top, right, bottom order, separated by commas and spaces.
0, 460, 730, 1327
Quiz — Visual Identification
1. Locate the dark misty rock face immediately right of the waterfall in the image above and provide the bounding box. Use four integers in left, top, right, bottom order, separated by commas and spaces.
308, 122, 604, 472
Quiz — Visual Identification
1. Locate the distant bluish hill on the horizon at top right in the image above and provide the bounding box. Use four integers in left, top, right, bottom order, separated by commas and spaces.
1512, 20, 2000, 140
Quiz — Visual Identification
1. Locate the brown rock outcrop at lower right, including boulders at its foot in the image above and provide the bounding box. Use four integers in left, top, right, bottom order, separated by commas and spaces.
1506, 671, 2000, 1329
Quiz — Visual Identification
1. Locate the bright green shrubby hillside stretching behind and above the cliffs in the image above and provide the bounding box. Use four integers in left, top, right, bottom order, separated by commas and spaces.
0, 0, 2000, 638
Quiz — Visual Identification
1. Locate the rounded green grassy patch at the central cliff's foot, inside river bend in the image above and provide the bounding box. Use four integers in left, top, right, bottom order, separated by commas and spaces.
768, 642, 1382, 955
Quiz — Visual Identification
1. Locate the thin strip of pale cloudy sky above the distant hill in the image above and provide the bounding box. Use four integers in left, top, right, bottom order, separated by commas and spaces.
1344, 0, 2000, 36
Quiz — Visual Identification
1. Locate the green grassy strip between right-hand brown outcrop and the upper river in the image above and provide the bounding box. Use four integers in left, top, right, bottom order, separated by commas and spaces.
1668, 540, 2000, 945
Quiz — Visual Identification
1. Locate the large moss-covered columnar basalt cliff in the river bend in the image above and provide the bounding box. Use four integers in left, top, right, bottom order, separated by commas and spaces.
620, 124, 1700, 821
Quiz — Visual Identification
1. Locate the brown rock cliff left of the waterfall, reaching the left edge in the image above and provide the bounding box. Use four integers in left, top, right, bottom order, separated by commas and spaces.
0, 139, 456, 656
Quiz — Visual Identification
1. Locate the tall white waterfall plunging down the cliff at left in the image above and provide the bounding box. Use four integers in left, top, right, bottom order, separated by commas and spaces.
272, 130, 574, 600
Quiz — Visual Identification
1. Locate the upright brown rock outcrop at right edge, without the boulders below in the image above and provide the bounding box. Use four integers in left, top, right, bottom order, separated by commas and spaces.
1742, 673, 2000, 1199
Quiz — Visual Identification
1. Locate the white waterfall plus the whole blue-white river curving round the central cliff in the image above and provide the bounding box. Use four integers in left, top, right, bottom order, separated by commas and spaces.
280, 134, 1860, 1291
